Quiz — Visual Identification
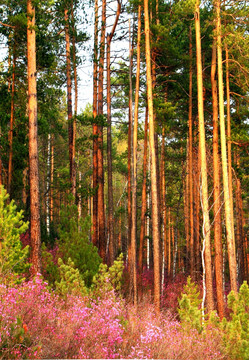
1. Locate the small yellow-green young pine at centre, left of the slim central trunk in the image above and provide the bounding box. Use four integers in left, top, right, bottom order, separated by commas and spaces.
92, 253, 124, 296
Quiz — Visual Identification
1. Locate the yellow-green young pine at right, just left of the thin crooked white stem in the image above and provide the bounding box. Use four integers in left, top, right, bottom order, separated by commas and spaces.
178, 276, 203, 333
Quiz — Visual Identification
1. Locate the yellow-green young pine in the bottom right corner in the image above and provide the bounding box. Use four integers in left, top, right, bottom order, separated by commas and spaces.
222, 281, 249, 360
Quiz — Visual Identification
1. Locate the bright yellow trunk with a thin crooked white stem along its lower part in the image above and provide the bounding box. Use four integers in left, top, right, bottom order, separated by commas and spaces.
195, 0, 214, 312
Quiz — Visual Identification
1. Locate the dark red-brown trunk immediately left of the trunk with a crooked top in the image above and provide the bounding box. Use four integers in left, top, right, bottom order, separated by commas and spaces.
98, 0, 106, 262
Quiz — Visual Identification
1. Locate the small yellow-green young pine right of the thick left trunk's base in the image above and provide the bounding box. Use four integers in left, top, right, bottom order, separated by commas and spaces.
55, 258, 87, 297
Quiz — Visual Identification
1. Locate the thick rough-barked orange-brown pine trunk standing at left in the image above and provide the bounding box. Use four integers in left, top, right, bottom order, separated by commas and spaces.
27, 0, 41, 275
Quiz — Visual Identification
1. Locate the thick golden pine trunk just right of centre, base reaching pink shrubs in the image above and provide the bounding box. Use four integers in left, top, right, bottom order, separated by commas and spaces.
144, 0, 160, 312
